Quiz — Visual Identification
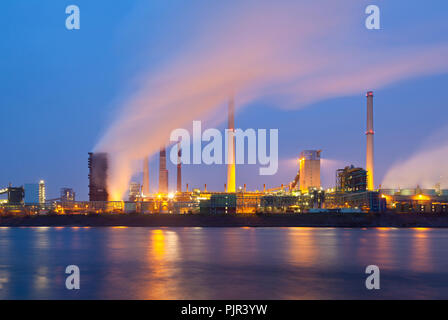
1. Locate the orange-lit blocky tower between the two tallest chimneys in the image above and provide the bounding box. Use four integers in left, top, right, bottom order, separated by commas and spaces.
299, 150, 322, 192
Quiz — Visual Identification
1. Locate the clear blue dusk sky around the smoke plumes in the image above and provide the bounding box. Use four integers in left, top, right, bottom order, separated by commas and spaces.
0, 0, 448, 200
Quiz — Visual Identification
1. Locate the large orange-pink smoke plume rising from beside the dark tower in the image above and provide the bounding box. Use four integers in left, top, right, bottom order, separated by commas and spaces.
95, 0, 448, 199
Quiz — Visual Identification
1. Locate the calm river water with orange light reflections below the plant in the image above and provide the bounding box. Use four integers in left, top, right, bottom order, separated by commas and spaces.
0, 227, 448, 299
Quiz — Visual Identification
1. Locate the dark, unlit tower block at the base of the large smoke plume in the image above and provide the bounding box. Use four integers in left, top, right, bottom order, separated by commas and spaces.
88, 152, 109, 201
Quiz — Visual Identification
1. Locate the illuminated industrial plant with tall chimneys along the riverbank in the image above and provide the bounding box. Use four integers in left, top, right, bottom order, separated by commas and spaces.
0, 91, 448, 214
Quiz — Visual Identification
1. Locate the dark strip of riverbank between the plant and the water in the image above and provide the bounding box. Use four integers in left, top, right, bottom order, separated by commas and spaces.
0, 212, 448, 228
